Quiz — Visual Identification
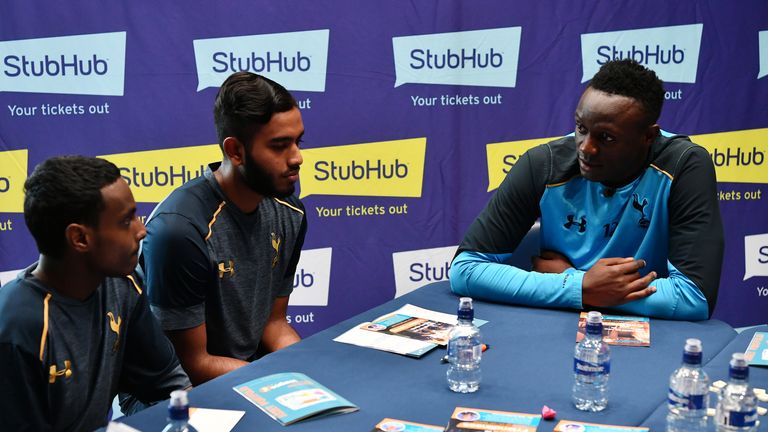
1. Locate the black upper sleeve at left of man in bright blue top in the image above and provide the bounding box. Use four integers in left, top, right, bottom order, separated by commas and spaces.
457, 145, 551, 254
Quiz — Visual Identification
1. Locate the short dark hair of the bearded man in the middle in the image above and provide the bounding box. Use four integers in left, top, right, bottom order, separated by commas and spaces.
213, 72, 297, 148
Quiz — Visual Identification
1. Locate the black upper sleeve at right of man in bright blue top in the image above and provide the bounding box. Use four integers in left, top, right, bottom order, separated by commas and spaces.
669, 146, 724, 316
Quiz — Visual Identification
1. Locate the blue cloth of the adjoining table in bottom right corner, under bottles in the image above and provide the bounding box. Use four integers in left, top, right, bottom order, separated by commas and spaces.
641, 325, 768, 431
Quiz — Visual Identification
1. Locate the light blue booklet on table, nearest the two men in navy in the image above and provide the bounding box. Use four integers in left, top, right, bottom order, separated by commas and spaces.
233, 372, 359, 426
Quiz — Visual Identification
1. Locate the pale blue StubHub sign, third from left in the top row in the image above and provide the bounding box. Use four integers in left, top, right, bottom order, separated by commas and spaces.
392, 27, 522, 87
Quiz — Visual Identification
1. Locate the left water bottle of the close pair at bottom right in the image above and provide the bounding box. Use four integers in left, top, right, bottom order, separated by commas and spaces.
667, 339, 709, 432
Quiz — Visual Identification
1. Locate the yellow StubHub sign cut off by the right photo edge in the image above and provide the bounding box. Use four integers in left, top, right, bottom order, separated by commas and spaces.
691, 129, 768, 183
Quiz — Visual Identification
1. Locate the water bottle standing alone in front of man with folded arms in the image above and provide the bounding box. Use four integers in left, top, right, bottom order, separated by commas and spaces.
572, 312, 611, 411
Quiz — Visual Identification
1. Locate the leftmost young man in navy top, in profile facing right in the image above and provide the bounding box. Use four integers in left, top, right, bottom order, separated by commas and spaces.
0, 156, 190, 431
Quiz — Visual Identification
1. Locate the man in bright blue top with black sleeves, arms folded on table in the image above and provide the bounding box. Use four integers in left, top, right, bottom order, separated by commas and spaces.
450, 60, 723, 320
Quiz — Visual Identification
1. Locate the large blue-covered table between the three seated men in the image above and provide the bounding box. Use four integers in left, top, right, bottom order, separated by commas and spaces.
119, 282, 736, 432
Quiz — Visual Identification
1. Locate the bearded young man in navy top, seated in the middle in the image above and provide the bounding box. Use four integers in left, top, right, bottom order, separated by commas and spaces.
140, 72, 307, 384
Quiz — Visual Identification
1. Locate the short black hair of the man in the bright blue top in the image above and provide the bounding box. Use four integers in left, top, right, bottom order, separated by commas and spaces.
589, 59, 664, 125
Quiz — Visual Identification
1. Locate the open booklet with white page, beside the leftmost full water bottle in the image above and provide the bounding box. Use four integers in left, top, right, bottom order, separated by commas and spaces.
334, 304, 487, 358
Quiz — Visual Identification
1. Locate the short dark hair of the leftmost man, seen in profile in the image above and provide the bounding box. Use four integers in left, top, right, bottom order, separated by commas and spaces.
24, 156, 120, 258
